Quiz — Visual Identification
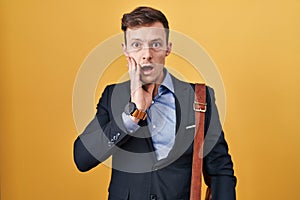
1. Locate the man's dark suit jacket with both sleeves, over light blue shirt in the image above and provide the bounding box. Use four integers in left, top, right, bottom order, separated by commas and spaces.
74, 76, 236, 200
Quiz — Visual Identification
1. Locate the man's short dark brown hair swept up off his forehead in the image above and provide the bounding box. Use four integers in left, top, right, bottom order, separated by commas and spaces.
121, 6, 169, 42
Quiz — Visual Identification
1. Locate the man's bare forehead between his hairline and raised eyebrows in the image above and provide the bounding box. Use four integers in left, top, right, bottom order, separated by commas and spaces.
126, 22, 166, 41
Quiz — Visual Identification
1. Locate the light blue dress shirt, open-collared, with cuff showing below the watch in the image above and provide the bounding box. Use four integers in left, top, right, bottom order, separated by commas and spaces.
122, 70, 176, 160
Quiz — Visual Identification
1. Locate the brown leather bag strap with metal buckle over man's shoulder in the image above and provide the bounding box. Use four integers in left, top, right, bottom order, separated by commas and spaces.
190, 84, 206, 200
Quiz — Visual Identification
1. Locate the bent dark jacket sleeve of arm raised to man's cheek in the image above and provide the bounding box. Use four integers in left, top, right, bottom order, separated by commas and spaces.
74, 85, 128, 172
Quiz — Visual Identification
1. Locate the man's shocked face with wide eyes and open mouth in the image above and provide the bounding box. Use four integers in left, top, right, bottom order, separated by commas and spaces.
123, 22, 171, 84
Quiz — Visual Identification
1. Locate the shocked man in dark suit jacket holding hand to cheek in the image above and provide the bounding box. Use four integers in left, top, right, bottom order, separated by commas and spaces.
74, 7, 236, 200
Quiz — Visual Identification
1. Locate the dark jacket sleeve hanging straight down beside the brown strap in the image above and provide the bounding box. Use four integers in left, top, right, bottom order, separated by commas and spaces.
203, 88, 236, 200
